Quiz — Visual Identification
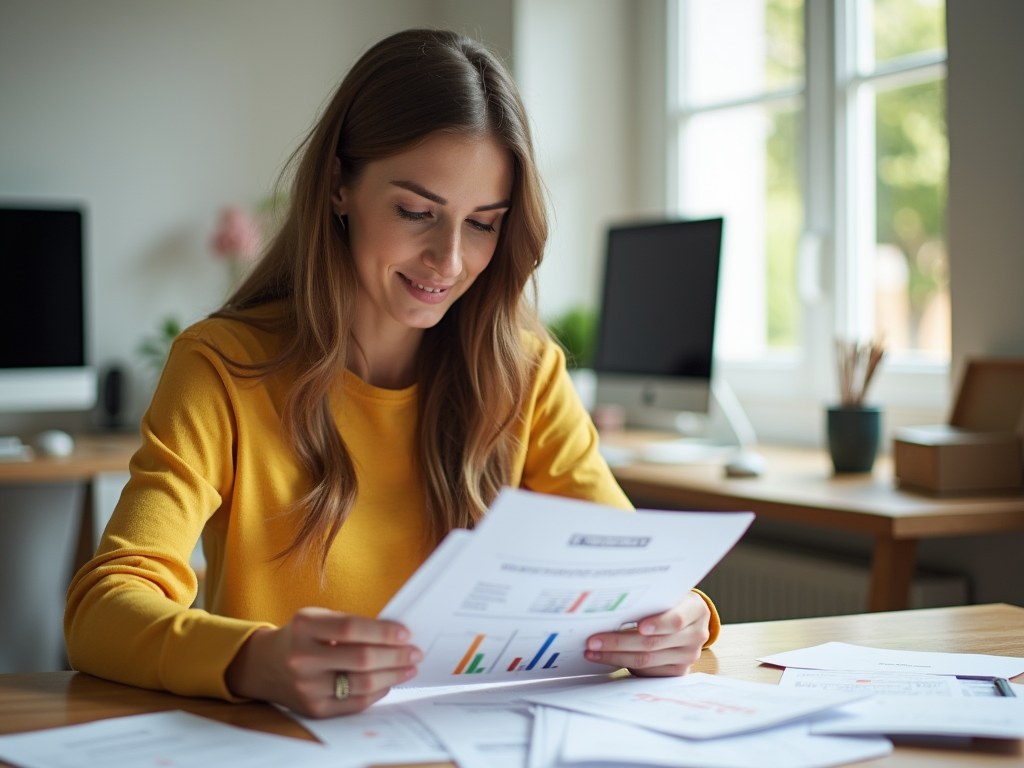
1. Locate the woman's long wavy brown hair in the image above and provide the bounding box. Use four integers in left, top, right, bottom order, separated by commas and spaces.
213, 30, 547, 571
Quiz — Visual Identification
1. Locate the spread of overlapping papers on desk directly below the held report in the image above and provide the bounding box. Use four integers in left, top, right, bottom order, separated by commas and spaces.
292, 674, 892, 768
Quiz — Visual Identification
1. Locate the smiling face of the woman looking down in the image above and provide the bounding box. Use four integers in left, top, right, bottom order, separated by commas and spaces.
334, 133, 512, 332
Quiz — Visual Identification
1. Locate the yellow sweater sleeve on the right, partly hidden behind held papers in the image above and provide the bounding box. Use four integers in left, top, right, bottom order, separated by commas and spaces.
522, 344, 722, 648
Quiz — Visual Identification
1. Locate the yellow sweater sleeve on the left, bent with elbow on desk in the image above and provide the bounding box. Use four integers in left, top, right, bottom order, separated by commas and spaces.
65, 332, 270, 699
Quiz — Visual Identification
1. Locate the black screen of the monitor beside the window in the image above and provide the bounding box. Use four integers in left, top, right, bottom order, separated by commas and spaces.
594, 218, 722, 379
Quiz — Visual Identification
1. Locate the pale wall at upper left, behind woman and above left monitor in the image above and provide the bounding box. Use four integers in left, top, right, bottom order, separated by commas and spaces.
0, 0, 437, 432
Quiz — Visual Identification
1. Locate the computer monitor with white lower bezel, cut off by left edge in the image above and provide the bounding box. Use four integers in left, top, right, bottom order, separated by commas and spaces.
0, 206, 96, 414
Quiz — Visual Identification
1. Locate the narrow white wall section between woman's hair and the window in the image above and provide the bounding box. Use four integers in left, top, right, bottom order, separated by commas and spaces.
514, 0, 639, 317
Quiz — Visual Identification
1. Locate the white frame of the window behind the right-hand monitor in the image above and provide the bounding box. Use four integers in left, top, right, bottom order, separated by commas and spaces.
666, 0, 950, 444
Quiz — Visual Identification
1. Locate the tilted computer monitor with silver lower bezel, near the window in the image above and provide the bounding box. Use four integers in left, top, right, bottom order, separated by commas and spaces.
594, 218, 723, 429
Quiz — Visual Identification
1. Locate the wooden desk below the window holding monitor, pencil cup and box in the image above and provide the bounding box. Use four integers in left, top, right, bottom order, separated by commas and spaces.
602, 432, 1024, 610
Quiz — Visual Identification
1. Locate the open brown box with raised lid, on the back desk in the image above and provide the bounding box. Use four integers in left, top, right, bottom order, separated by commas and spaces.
893, 359, 1024, 494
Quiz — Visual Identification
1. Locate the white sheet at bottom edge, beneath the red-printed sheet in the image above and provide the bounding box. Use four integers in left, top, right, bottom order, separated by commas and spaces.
561, 714, 892, 768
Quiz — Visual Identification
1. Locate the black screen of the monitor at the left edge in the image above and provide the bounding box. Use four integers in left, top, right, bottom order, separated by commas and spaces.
0, 208, 85, 369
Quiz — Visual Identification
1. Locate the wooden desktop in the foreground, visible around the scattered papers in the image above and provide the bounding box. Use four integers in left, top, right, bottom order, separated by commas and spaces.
0, 605, 1024, 768
